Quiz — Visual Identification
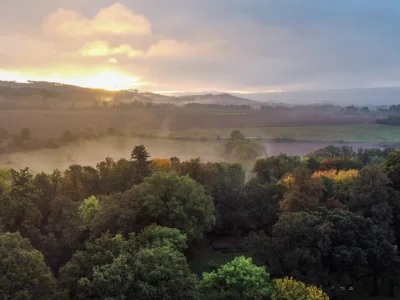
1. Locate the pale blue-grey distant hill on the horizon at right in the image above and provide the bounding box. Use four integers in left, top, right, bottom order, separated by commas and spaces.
236, 87, 400, 106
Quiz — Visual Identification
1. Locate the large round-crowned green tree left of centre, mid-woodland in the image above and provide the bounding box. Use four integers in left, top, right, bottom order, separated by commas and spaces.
119, 173, 215, 242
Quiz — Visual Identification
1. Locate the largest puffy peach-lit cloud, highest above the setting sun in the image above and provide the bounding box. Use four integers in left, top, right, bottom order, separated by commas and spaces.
43, 3, 151, 37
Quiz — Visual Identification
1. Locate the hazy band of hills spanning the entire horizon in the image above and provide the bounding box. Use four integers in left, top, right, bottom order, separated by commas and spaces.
0, 81, 400, 108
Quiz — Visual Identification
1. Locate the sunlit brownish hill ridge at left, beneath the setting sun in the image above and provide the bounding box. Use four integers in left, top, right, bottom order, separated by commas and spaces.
0, 81, 261, 108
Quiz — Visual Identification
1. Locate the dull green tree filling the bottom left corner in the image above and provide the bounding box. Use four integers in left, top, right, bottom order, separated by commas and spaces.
0, 233, 52, 300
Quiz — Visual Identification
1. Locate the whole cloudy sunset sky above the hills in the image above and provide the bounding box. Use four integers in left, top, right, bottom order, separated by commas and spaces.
0, 0, 400, 93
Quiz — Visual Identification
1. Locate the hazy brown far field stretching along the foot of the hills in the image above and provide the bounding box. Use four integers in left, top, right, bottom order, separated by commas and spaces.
0, 109, 376, 140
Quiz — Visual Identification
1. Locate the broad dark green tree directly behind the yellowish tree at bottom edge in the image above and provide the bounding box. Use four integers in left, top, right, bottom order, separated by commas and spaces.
247, 212, 333, 284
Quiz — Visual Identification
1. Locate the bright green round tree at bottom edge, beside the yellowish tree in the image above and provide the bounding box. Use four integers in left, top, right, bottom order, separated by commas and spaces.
201, 256, 273, 300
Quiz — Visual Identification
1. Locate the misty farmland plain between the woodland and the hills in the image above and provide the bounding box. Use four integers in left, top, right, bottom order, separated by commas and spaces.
0, 109, 400, 171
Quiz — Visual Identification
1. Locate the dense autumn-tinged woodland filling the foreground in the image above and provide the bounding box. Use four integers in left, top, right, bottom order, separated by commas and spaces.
0, 131, 400, 300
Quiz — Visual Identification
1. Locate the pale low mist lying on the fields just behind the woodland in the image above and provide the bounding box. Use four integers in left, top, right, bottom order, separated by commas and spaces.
0, 137, 377, 173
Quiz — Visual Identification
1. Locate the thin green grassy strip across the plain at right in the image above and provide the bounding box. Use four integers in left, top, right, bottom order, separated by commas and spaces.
142, 123, 400, 143
